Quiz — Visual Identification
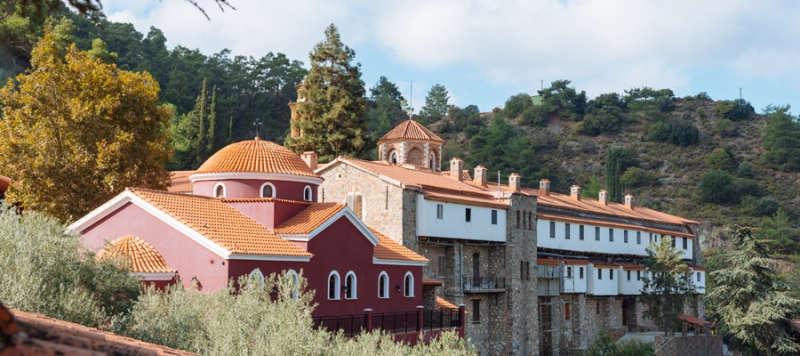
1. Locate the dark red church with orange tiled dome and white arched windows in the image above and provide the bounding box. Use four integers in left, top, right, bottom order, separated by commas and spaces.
69, 138, 427, 316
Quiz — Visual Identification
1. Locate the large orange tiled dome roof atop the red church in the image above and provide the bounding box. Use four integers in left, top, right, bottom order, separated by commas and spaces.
195, 139, 319, 178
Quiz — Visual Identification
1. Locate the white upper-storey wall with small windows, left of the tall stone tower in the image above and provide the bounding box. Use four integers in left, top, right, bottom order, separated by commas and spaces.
417, 194, 506, 242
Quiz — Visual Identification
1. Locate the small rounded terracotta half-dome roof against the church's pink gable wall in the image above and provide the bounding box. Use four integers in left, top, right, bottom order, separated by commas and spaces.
97, 235, 175, 273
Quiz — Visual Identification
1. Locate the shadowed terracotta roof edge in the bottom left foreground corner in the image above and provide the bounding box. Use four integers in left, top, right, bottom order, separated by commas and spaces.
0, 303, 195, 356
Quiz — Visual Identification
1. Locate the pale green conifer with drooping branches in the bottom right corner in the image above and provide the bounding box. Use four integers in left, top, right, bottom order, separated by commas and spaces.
707, 225, 800, 355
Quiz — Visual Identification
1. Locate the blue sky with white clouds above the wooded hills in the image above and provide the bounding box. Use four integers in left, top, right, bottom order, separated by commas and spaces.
103, 0, 800, 113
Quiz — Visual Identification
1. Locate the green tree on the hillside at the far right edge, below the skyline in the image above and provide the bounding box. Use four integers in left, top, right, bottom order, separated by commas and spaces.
761, 105, 800, 171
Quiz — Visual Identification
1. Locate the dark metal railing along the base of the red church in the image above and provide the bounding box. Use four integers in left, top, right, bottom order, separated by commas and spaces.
313, 309, 464, 337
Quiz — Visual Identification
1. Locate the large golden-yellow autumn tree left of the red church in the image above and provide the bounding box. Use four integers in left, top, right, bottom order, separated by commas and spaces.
0, 25, 171, 221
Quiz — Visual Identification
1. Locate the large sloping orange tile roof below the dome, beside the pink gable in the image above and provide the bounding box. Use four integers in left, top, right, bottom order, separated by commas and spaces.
128, 188, 311, 257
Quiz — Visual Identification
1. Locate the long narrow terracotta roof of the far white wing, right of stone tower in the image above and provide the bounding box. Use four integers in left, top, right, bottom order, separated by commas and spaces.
522, 188, 699, 225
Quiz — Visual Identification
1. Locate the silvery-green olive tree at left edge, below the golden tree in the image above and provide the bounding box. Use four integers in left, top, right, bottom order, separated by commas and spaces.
0, 203, 139, 326
